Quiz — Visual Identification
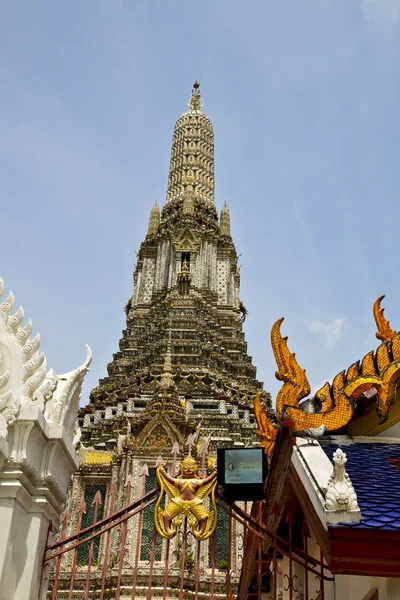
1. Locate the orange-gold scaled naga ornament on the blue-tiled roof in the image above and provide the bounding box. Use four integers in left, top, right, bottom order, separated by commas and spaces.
254, 296, 400, 454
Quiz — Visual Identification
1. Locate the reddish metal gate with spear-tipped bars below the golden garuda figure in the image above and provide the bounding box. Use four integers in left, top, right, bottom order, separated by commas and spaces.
39, 486, 333, 600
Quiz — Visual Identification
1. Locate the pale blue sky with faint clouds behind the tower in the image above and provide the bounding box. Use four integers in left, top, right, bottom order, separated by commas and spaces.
0, 0, 400, 402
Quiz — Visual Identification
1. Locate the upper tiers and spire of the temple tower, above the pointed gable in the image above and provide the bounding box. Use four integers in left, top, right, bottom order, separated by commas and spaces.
79, 82, 262, 449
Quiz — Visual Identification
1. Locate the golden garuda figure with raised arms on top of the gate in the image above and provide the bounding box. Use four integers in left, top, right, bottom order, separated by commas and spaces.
154, 455, 217, 540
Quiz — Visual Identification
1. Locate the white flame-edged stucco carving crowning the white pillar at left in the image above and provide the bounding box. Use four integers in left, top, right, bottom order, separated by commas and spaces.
0, 278, 91, 439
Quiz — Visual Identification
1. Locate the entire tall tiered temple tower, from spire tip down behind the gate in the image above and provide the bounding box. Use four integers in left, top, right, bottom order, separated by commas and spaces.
60, 82, 269, 598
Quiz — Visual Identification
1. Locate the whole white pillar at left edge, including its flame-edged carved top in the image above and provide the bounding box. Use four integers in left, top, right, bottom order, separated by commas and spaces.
0, 279, 92, 600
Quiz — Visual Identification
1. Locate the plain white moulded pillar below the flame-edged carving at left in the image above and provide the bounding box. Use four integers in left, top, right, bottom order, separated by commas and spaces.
0, 411, 78, 600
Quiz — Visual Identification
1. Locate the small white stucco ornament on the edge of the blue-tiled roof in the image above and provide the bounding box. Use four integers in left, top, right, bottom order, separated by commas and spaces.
325, 448, 361, 523
